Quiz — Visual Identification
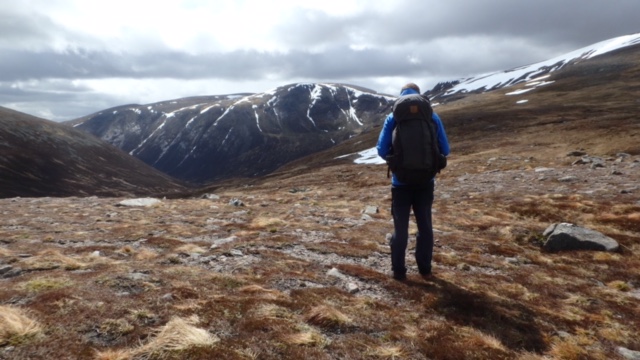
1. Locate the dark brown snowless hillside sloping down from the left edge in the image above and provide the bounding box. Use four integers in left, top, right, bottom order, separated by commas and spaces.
0, 107, 185, 198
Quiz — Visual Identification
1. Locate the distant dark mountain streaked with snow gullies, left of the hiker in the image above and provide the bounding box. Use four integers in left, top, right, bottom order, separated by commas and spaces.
67, 84, 394, 183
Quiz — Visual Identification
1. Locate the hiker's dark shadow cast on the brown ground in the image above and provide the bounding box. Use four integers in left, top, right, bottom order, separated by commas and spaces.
405, 277, 548, 353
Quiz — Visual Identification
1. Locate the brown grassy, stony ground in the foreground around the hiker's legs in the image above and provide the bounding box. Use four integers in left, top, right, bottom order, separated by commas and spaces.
0, 148, 640, 359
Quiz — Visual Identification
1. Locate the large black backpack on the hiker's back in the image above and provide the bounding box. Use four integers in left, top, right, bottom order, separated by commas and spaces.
386, 94, 447, 185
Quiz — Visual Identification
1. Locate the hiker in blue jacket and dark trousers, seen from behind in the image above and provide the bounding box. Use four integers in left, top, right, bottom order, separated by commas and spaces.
377, 83, 449, 281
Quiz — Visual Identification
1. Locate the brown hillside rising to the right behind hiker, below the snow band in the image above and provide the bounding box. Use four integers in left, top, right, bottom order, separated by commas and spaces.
265, 34, 640, 180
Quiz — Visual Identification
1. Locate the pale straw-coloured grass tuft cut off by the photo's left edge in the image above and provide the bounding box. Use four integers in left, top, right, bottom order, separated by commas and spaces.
0, 305, 42, 346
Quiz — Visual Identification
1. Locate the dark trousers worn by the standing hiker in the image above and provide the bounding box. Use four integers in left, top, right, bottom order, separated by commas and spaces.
391, 181, 434, 276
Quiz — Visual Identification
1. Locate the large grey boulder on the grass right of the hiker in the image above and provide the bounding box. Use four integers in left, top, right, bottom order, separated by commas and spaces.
542, 223, 620, 252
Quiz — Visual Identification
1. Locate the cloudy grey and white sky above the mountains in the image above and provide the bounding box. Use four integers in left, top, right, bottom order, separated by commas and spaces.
0, 0, 640, 121
